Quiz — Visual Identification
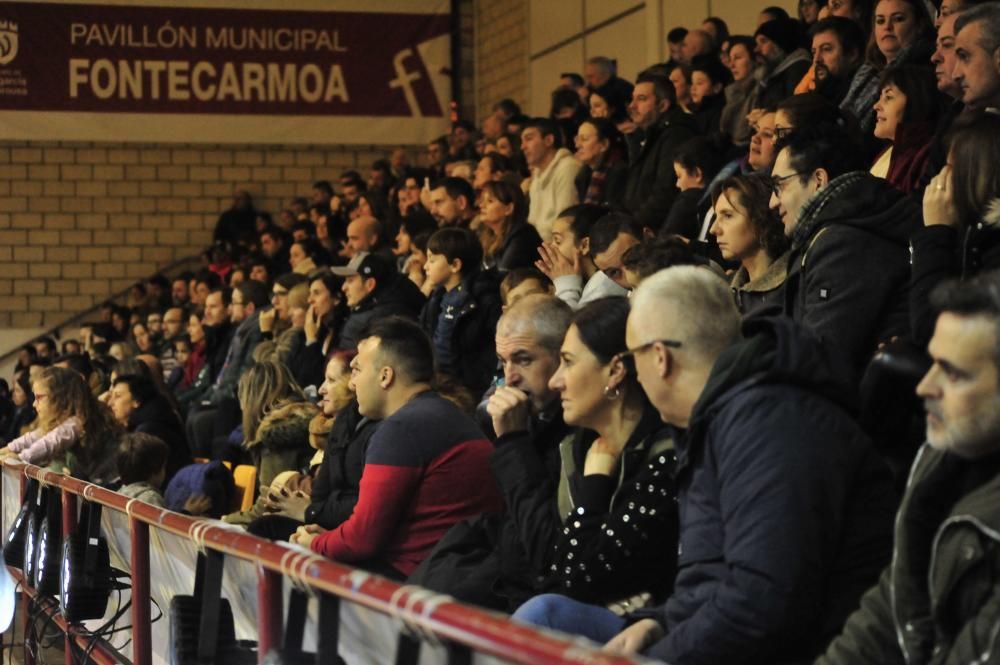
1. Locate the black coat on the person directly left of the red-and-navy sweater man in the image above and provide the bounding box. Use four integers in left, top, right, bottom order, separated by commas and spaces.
305, 400, 379, 529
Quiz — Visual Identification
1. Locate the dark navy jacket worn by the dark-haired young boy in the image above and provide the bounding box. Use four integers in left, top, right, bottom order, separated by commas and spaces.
420, 270, 503, 396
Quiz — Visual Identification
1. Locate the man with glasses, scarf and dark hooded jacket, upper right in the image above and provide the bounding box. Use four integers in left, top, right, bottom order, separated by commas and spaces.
771, 123, 921, 377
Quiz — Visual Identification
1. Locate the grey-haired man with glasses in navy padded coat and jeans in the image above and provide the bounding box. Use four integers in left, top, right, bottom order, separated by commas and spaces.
516, 266, 895, 664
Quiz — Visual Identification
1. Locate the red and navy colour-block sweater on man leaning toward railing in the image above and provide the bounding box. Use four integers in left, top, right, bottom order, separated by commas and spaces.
312, 391, 503, 576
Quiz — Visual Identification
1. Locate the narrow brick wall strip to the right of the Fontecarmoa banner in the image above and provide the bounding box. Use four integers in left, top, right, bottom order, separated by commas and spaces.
476, 0, 528, 121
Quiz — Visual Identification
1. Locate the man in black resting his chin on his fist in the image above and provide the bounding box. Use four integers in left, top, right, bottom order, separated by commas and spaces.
409, 295, 572, 611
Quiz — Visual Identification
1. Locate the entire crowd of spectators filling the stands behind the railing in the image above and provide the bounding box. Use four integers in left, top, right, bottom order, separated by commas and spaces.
0, 0, 1000, 665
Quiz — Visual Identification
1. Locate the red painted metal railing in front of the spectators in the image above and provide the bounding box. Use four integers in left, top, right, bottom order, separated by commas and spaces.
0, 461, 635, 665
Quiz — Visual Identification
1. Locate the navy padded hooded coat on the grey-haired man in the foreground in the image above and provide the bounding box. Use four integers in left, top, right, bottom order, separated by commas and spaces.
633, 317, 895, 665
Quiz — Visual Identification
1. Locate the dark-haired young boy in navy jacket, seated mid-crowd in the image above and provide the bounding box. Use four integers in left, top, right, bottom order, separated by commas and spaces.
420, 227, 501, 395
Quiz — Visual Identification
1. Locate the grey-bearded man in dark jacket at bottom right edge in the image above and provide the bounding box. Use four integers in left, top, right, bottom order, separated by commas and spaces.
818, 273, 1000, 665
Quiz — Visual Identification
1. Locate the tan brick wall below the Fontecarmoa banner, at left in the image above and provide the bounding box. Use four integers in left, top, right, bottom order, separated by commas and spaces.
0, 142, 410, 328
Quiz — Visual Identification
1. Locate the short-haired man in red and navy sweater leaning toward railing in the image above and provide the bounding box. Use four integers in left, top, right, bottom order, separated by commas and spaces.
292, 317, 503, 579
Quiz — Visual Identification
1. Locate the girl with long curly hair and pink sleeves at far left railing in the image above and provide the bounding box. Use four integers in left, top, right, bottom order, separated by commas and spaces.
2, 367, 122, 484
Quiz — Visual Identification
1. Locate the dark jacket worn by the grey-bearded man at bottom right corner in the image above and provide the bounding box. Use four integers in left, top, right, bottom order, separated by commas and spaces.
817, 444, 1000, 665
